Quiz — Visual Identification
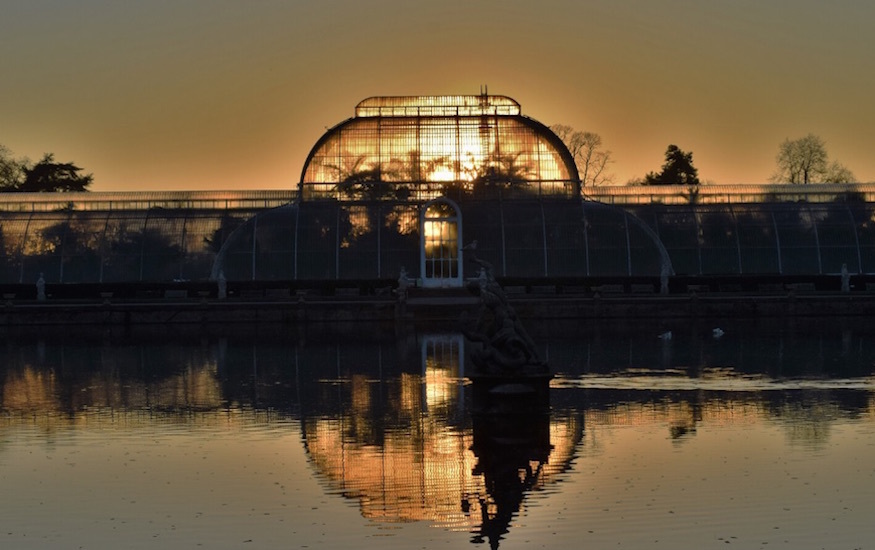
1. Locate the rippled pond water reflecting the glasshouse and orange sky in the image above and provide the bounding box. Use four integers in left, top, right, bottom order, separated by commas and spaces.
0, 319, 875, 549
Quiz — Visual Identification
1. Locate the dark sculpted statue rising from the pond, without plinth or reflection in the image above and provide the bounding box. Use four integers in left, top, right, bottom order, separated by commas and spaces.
462, 250, 545, 374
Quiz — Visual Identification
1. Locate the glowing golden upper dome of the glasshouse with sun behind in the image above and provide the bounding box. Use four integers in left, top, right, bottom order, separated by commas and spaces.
299, 95, 580, 200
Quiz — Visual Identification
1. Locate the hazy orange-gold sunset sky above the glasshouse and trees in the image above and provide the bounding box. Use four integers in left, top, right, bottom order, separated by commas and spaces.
0, 0, 875, 191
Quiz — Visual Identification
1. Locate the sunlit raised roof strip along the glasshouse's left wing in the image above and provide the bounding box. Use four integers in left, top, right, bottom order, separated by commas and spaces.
0, 190, 297, 212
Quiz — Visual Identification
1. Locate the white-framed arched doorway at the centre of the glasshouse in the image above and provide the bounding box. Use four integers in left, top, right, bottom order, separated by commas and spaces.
420, 198, 462, 287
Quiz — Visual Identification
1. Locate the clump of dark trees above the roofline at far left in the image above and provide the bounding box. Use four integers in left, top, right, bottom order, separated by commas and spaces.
0, 144, 94, 193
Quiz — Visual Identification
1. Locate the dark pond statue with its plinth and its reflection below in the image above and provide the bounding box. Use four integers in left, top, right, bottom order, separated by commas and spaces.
462, 247, 552, 549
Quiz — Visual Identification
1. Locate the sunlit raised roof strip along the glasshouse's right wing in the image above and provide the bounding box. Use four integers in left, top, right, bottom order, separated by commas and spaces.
581, 183, 875, 206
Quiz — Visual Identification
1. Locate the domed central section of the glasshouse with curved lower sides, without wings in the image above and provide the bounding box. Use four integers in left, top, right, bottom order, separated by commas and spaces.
213, 95, 670, 287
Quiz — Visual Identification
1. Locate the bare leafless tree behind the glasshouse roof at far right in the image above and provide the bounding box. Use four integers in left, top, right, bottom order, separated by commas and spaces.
771, 134, 855, 184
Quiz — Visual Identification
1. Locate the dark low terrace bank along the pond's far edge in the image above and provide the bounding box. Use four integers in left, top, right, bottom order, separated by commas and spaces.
0, 289, 875, 327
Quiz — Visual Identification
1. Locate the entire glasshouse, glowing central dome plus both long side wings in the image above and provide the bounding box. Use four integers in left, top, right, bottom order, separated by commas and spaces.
0, 95, 875, 286
